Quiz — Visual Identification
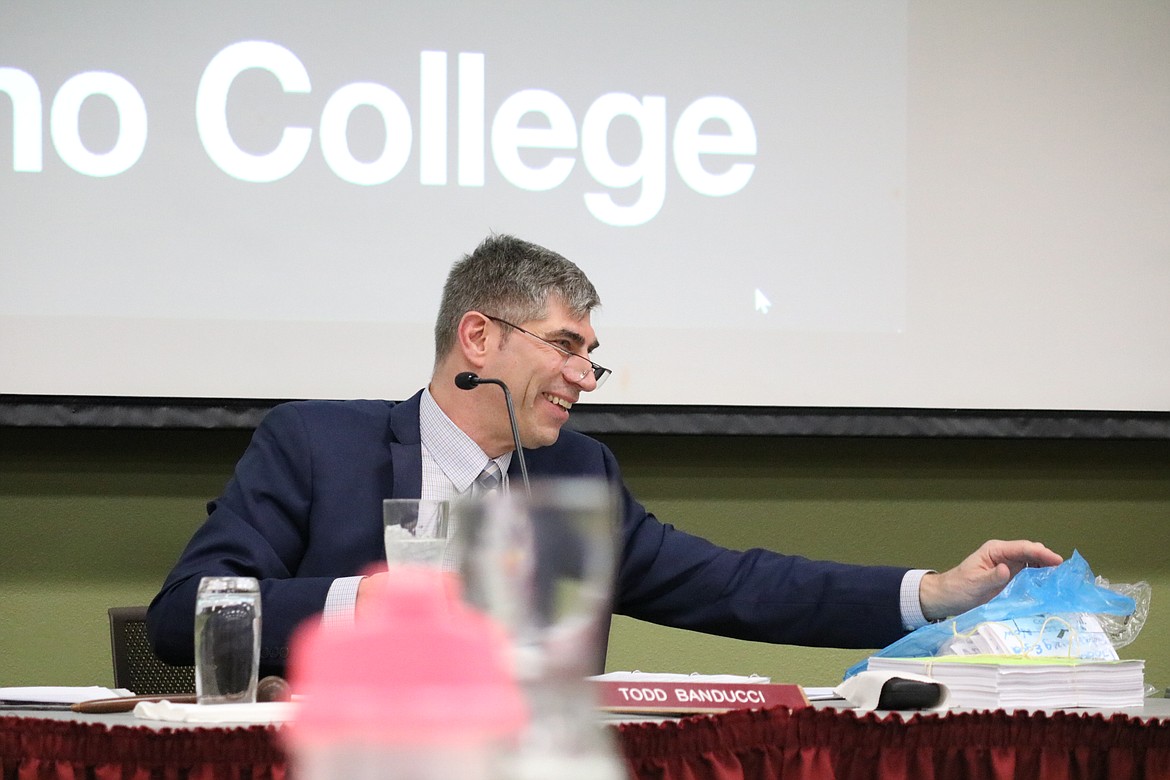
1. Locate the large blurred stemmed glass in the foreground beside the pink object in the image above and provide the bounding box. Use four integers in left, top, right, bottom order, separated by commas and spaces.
452, 478, 626, 780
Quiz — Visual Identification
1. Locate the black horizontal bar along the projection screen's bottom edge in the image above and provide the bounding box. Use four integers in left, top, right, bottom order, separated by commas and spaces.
0, 395, 1170, 440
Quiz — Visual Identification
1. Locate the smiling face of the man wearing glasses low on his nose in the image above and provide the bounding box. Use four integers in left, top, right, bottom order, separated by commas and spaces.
482, 298, 598, 449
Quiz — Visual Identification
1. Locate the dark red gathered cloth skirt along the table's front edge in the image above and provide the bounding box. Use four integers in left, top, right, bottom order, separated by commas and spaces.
0, 707, 1170, 780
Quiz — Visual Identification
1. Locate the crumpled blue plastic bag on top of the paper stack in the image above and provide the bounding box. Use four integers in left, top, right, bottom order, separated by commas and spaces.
845, 550, 1136, 679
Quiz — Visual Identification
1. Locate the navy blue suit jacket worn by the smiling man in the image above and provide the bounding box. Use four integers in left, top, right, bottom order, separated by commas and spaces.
147, 394, 906, 674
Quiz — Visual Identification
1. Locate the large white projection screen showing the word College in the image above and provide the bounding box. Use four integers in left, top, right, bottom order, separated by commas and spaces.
0, 0, 1170, 432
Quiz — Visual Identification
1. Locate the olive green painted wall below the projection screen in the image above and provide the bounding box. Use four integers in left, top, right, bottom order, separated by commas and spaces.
0, 428, 1170, 689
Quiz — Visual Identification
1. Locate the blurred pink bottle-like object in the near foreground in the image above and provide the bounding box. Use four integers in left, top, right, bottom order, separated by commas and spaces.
284, 566, 528, 780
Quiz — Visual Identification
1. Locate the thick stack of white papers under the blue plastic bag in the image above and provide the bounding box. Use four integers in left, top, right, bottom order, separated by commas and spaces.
868, 655, 1145, 710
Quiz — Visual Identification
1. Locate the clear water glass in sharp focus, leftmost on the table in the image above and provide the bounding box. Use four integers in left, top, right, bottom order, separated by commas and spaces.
195, 577, 260, 704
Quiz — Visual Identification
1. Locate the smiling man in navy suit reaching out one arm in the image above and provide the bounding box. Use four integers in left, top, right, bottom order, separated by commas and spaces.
147, 235, 1061, 674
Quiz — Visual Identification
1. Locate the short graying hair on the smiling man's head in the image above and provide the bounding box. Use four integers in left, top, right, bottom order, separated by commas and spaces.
435, 234, 601, 365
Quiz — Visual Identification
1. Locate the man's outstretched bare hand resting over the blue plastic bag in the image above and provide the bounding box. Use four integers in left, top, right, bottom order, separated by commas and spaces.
918, 539, 1064, 620
